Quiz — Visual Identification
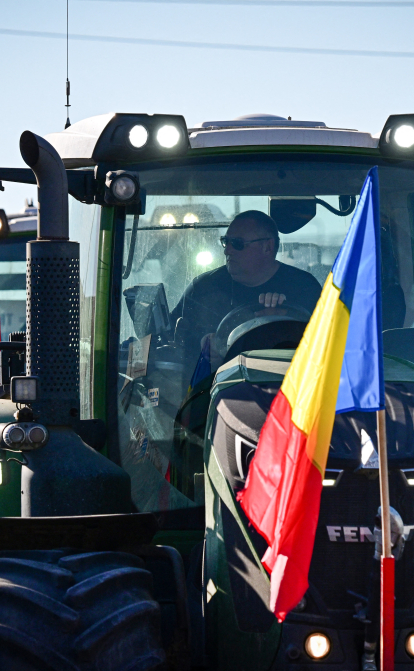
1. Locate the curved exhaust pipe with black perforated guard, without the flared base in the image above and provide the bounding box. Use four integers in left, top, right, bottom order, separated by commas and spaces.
20, 131, 80, 426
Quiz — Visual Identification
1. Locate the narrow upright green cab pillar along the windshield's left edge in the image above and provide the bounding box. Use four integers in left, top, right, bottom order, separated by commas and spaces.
93, 207, 114, 438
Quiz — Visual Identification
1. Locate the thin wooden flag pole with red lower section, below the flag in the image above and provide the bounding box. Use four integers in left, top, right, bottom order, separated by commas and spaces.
377, 410, 394, 671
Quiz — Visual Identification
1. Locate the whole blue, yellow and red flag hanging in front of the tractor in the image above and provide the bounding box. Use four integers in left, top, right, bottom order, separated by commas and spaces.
238, 168, 384, 622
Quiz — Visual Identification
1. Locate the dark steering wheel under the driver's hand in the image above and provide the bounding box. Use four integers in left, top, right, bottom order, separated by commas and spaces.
215, 303, 311, 357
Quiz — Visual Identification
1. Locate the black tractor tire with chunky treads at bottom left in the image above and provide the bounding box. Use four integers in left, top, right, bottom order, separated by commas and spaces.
0, 549, 167, 671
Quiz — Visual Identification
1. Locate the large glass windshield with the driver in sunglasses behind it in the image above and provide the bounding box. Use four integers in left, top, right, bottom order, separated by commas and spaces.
117, 154, 414, 511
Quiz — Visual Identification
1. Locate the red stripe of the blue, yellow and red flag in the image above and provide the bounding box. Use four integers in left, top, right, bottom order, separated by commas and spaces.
238, 391, 322, 622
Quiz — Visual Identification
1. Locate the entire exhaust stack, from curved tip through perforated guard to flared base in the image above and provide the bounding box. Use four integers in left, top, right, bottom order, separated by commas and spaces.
20, 131, 131, 517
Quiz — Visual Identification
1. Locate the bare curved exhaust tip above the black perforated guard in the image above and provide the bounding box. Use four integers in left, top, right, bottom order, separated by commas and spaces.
20, 130, 69, 240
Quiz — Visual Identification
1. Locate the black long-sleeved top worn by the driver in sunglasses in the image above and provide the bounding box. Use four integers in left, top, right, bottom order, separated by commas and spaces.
171, 263, 321, 351
